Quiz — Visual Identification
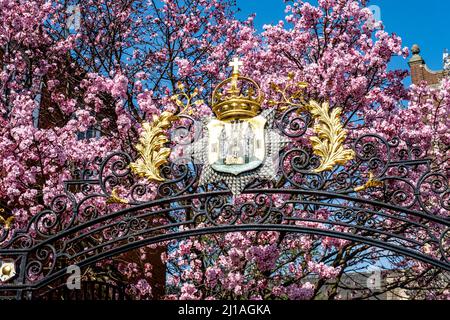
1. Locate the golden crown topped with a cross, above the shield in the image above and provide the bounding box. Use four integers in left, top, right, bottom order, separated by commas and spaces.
212, 58, 264, 120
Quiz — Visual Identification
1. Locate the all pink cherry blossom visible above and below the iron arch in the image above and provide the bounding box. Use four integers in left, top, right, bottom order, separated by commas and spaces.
0, 0, 450, 299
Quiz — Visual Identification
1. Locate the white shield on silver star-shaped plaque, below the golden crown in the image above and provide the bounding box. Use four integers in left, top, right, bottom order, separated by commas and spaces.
192, 110, 289, 195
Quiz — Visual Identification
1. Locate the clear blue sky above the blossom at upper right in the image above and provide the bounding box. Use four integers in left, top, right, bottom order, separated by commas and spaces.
237, 0, 450, 80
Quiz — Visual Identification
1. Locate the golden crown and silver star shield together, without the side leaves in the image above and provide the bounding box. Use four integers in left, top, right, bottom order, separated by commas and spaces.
189, 59, 289, 195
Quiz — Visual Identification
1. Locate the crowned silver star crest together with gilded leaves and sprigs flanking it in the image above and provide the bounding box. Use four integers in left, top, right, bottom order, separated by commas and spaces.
128, 58, 354, 192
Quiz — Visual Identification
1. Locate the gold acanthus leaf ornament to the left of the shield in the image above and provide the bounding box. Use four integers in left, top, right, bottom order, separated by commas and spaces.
130, 111, 178, 182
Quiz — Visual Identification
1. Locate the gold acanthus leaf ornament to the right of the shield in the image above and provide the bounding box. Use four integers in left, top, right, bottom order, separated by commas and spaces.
308, 100, 355, 173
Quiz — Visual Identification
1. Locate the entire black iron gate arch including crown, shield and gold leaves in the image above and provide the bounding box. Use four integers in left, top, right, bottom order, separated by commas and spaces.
0, 60, 450, 299
